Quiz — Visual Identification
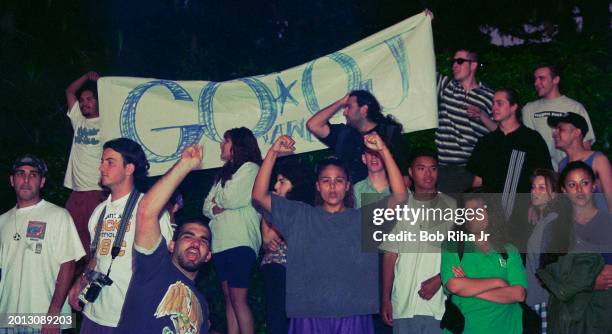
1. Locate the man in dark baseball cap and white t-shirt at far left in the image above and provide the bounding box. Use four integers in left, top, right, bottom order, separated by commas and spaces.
0, 154, 85, 333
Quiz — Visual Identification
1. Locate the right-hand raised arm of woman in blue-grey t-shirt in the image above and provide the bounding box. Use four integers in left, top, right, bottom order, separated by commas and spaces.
363, 132, 406, 202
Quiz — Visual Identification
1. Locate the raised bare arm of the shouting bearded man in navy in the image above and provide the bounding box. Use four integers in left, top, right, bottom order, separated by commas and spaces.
134, 145, 204, 249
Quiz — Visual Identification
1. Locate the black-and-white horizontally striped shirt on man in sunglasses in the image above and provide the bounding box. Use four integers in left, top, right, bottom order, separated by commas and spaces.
436, 74, 495, 165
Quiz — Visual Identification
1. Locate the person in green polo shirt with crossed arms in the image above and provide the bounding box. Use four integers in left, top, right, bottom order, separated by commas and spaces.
440, 193, 527, 334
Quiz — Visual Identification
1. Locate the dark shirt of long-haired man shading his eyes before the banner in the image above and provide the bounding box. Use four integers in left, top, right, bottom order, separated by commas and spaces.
321, 124, 409, 184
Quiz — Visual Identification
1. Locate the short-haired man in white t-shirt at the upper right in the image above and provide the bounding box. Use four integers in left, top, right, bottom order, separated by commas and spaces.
523, 64, 595, 170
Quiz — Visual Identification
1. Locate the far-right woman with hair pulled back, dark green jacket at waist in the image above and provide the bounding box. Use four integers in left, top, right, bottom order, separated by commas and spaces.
538, 161, 612, 334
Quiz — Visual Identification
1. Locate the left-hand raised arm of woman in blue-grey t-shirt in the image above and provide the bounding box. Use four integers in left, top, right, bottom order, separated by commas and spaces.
251, 135, 295, 212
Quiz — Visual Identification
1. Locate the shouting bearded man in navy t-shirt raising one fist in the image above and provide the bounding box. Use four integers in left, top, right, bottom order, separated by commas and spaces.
118, 146, 212, 334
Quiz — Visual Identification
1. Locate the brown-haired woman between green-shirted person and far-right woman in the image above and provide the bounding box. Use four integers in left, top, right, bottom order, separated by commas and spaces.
526, 169, 567, 334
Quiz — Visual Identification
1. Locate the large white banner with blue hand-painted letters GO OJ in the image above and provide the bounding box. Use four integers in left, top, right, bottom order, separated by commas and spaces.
98, 14, 438, 175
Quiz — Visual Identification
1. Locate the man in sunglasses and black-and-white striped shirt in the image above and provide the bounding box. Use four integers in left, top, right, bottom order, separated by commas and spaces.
436, 49, 497, 194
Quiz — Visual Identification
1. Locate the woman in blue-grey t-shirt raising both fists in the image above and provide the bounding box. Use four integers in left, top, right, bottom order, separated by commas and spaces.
253, 133, 405, 334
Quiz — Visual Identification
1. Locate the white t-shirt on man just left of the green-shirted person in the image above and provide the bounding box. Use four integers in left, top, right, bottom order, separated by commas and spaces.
380, 193, 457, 320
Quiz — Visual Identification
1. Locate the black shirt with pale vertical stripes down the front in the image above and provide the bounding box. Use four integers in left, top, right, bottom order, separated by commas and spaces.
467, 124, 552, 193
